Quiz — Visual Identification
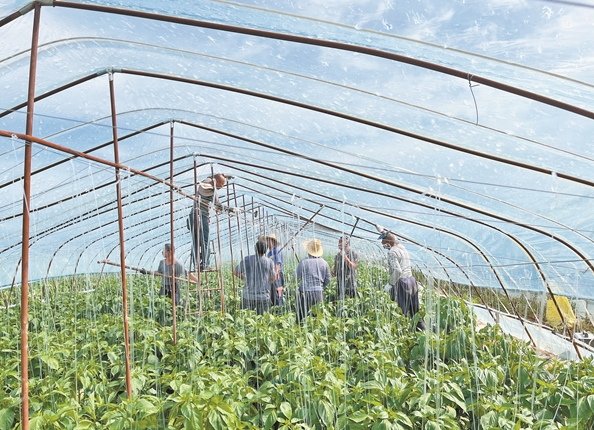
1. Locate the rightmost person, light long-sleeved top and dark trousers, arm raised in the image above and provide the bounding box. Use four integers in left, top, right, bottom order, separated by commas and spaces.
376, 225, 425, 330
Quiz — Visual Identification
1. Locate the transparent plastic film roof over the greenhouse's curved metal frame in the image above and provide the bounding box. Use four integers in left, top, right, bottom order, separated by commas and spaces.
0, 0, 594, 299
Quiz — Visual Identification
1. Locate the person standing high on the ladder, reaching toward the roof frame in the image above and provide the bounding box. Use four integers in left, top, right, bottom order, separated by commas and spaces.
187, 173, 227, 272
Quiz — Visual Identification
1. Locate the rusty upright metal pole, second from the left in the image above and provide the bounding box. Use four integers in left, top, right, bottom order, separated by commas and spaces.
109, 72, 132, 398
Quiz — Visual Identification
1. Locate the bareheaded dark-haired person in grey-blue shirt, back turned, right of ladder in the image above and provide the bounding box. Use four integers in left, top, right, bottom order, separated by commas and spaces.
233, 240, 274, 315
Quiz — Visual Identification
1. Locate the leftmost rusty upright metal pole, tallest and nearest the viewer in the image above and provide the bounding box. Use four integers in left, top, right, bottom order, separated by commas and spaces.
21, 3, 41, 430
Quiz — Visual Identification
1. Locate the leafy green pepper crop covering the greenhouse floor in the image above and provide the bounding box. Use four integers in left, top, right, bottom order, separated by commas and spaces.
0, 266, 594, 430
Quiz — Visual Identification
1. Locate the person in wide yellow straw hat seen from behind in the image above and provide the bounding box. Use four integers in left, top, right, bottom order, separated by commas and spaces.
295, 239, 330, 323
